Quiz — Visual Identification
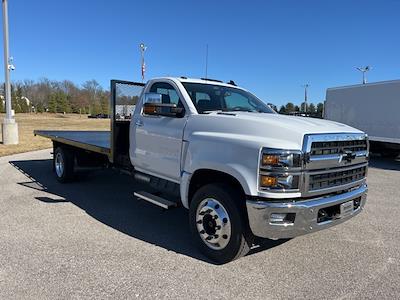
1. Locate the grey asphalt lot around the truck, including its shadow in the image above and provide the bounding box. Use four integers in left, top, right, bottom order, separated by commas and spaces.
0, 150, 400, 299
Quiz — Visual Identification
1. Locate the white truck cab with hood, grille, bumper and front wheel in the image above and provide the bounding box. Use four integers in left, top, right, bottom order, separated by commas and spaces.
37, 77, 369, 263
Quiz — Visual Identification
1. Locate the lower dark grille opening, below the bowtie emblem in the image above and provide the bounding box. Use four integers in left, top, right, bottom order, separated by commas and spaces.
308, 166, 367, 191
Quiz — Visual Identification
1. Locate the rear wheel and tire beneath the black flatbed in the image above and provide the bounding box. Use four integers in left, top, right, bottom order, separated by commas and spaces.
53, 147, 75, 183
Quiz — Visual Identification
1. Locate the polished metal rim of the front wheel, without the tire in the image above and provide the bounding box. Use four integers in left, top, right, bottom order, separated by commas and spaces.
196, 198, 231, 250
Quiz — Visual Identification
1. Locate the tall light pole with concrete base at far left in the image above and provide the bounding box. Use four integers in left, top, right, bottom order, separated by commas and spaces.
2, 0, 18, 145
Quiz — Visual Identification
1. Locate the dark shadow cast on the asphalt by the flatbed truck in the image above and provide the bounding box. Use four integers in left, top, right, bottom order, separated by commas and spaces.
10, 159, 286, 264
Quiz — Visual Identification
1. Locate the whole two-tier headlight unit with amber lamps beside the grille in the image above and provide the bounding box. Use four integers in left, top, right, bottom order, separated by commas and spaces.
259, 149, 302, 192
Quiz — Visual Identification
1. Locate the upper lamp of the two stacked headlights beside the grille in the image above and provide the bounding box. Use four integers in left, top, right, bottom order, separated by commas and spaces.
261, 149, 301, 169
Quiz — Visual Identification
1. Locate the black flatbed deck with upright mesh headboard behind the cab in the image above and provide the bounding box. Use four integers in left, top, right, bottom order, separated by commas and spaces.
34, 80, 145, 169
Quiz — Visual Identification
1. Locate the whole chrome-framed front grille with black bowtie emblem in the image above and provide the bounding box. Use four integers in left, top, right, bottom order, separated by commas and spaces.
302, 133, 369, 196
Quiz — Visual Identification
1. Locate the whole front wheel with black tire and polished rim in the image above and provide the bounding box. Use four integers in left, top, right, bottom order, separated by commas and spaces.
189, 184, 251, 263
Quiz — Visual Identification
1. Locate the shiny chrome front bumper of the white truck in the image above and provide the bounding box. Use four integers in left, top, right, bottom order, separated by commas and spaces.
246, 184, 368, 239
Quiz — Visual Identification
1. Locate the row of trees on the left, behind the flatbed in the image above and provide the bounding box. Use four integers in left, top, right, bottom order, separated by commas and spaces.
0, 78, 110, 115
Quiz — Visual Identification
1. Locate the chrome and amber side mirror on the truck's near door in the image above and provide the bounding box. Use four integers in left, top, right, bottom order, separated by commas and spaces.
143, 93, 183, 118
